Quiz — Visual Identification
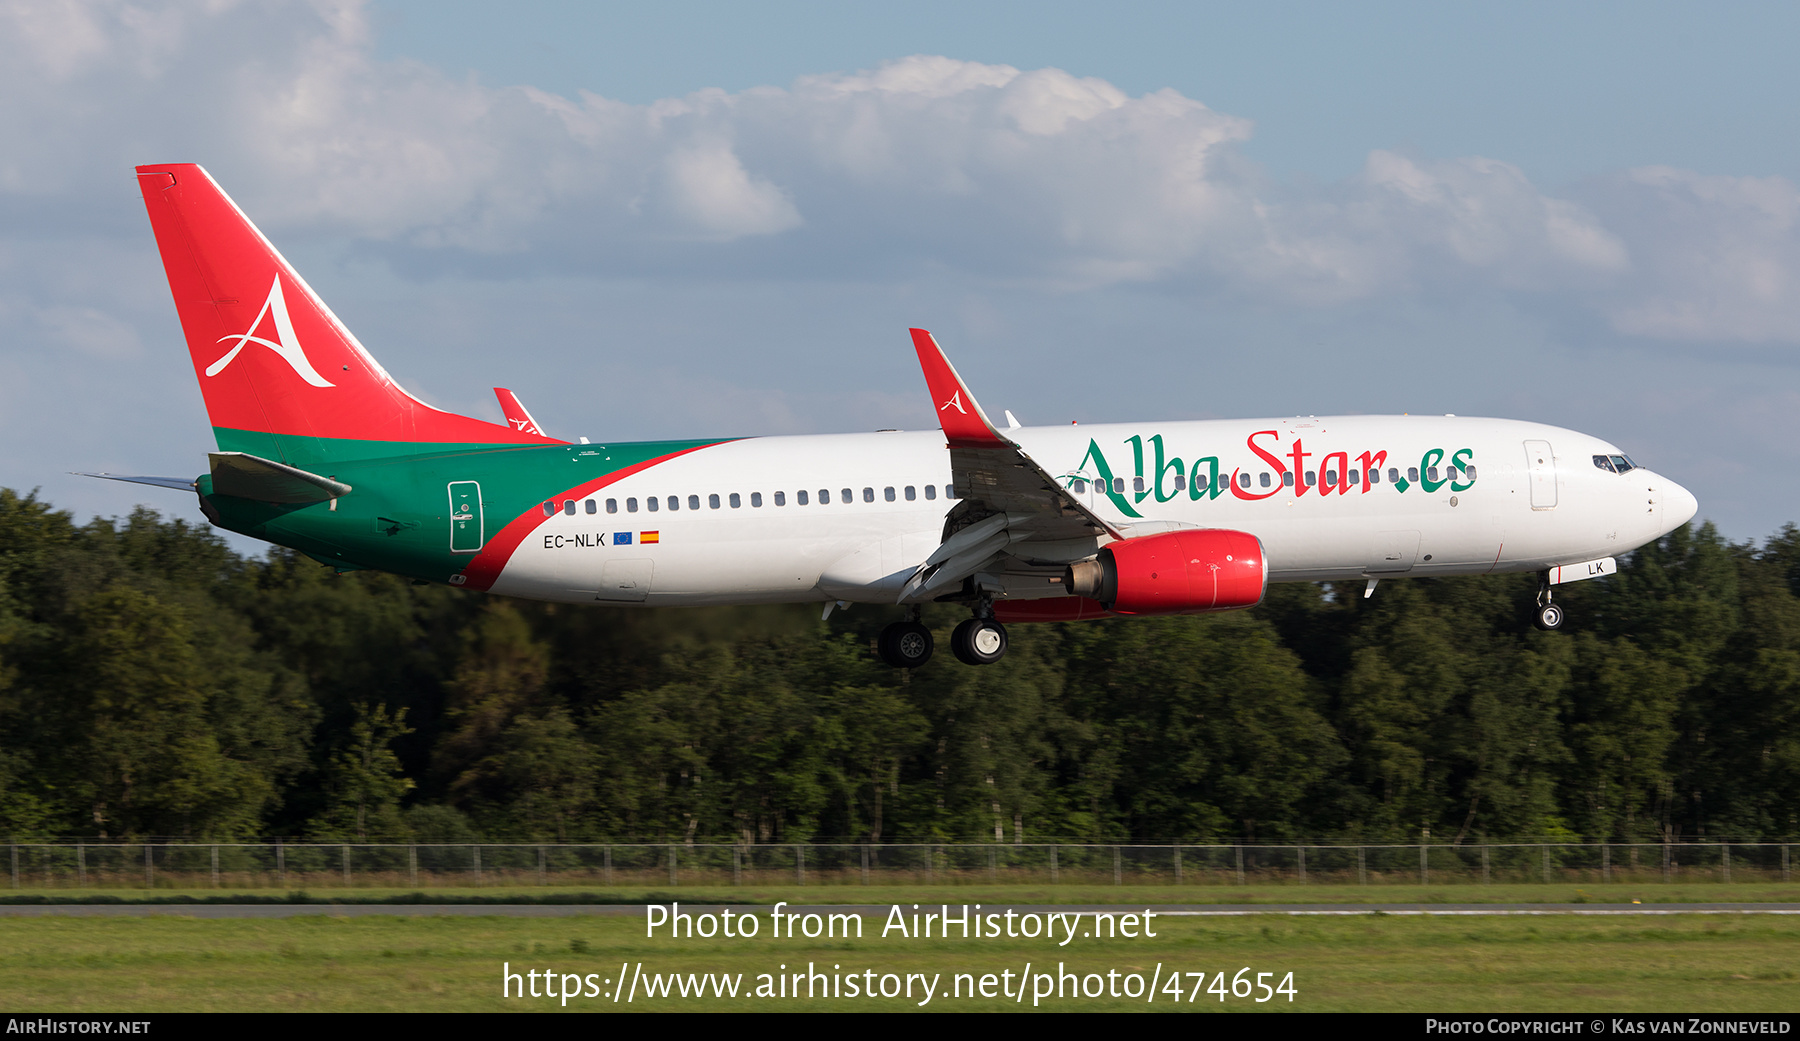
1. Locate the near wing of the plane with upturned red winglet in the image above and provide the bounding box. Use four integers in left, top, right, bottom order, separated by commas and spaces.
900, 330, 1125, 600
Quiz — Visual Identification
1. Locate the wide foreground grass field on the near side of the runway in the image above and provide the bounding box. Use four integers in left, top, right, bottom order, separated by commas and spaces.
0, 911, 1800, 1012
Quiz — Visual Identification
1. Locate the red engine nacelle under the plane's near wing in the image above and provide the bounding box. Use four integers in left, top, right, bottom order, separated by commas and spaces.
1064, 528, 1269, 614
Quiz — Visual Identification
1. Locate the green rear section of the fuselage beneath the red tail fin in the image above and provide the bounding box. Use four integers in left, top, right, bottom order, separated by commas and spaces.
200, 430, 722, 582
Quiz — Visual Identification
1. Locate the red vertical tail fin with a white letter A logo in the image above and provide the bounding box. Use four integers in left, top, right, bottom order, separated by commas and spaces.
137, 164, 563, 461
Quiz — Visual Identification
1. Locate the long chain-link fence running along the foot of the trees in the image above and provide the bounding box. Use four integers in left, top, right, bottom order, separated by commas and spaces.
9, 843, 1789, 890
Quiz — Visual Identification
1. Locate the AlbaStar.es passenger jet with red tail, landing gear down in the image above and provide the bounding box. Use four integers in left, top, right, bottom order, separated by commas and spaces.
94, 164, 1699, 668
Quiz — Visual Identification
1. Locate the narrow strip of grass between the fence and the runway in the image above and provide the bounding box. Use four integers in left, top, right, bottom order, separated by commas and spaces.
10, 883, 1800, 904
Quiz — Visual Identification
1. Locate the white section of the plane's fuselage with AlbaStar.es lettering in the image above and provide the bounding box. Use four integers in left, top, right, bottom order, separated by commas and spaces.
493, 416, 1697, 607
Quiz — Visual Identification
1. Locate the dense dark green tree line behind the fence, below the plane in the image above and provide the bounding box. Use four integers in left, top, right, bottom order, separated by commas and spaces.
0, 490, 1800, 841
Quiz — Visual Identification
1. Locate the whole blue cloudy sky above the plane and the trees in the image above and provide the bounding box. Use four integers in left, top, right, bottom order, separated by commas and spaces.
0, 0, 1800, 539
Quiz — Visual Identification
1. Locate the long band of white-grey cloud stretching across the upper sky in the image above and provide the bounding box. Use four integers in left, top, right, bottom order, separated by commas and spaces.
0, 0, 1800, 342
